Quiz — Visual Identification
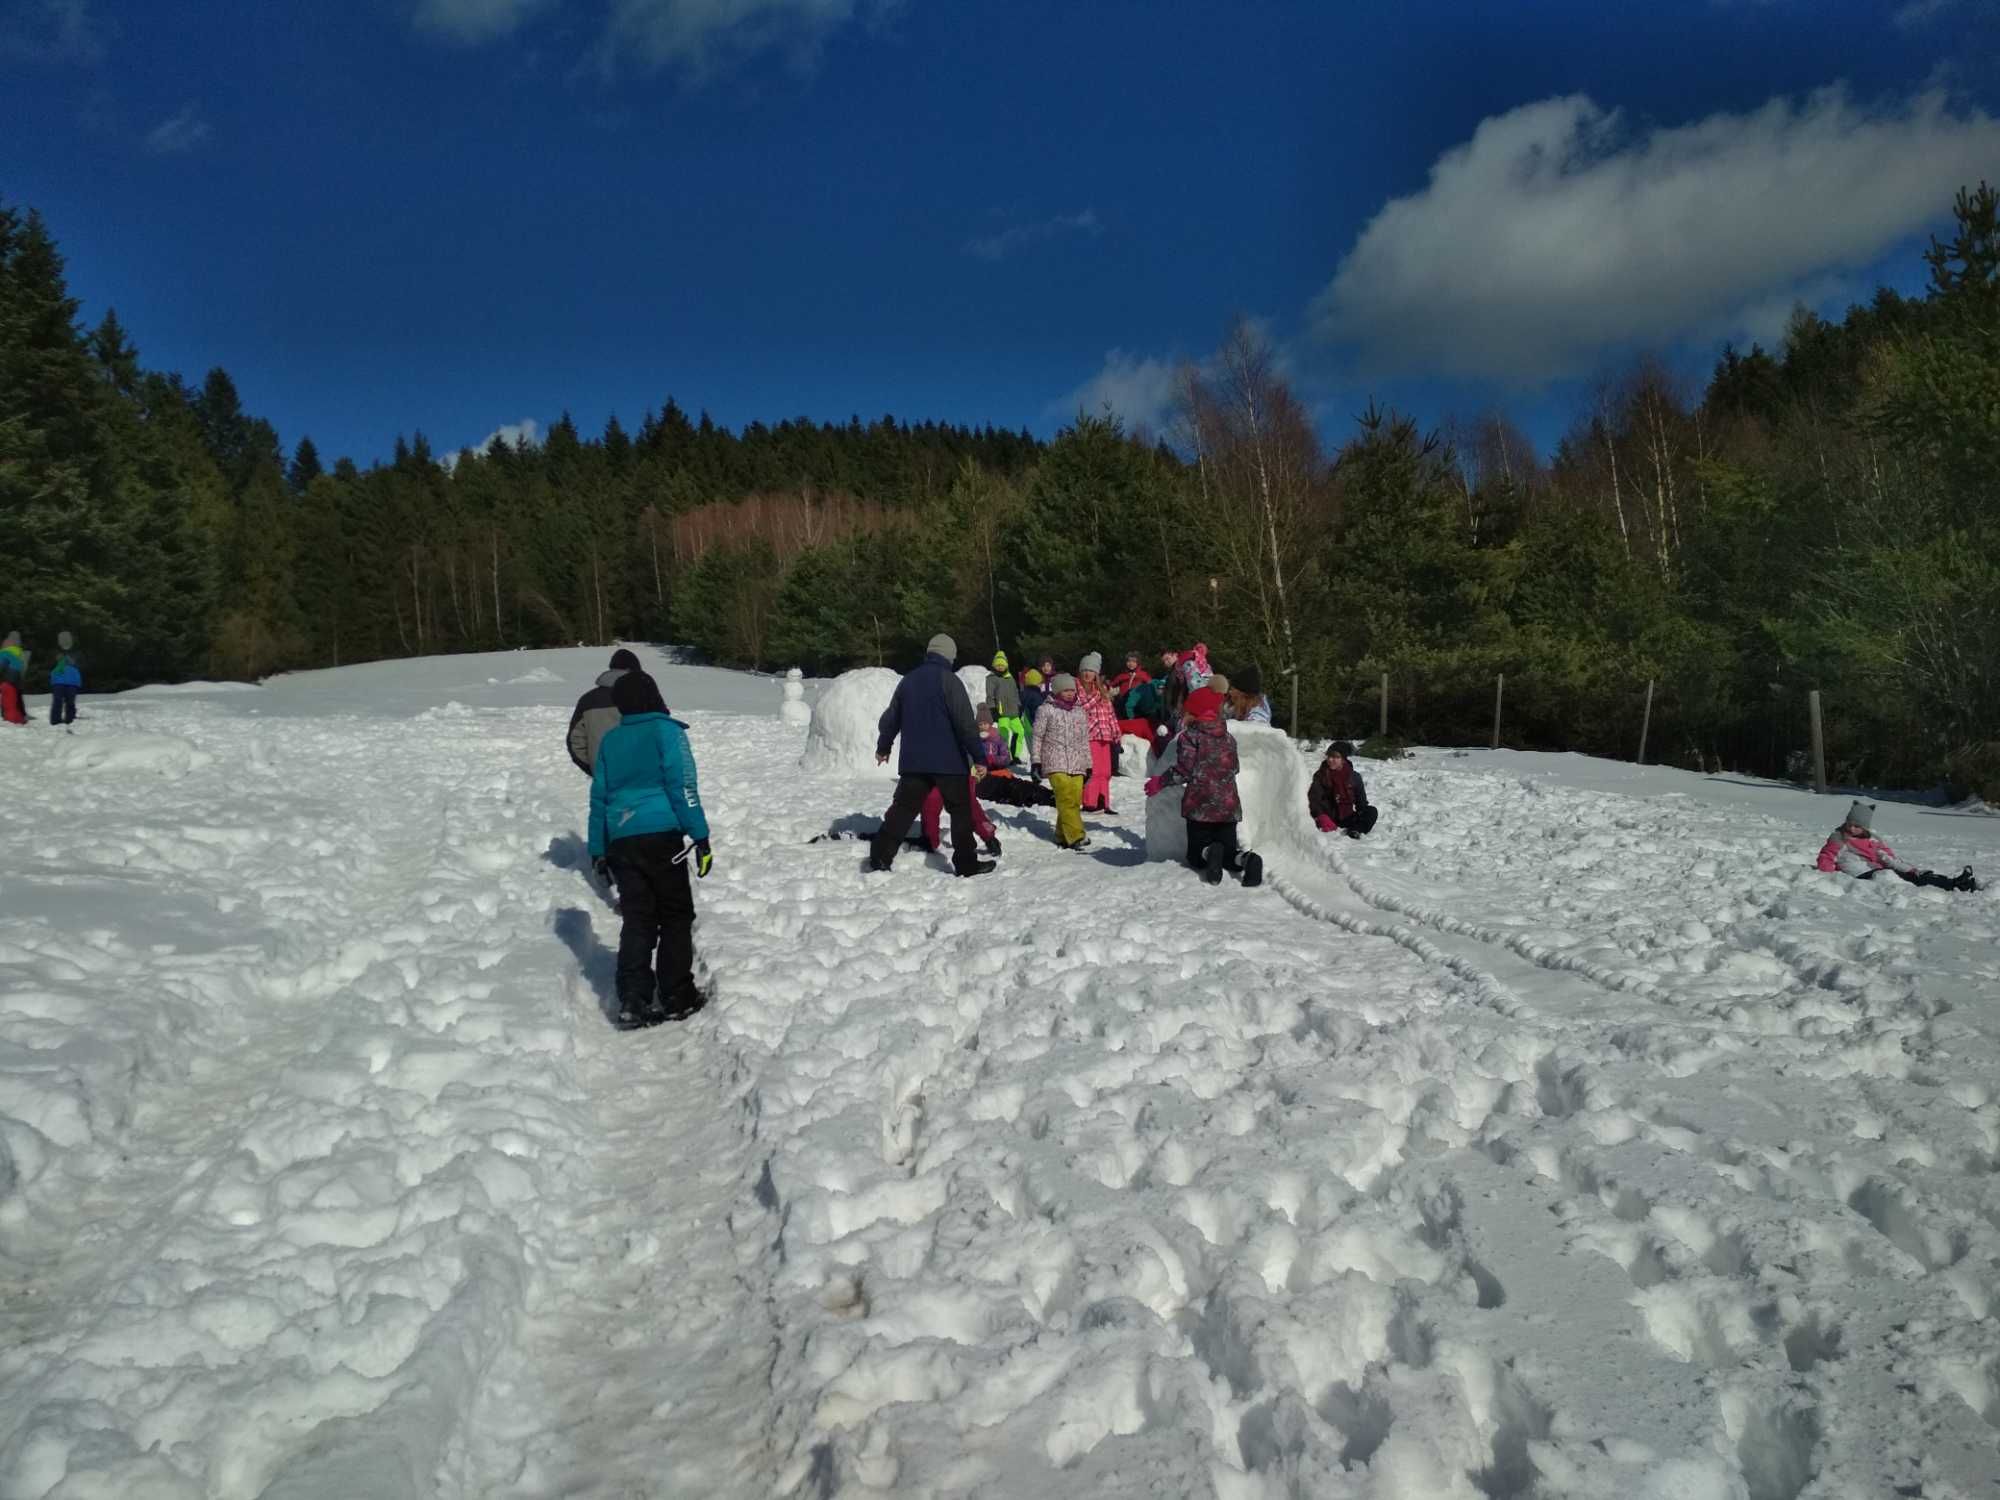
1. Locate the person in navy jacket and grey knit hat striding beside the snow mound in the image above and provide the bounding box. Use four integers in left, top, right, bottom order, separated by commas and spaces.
868, 634, 994, 876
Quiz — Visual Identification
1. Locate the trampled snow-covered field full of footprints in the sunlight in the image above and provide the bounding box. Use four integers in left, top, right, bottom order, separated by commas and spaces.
0, 652, 2000, 1500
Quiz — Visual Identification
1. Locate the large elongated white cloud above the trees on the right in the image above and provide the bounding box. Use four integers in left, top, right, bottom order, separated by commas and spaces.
1314, 88, 2000, 382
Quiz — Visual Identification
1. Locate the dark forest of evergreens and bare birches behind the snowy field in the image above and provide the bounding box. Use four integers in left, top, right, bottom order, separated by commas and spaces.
0, 184, 2000, 792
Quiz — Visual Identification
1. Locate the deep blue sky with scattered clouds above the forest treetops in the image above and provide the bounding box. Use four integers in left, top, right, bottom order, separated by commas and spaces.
0, 0, 2000, 462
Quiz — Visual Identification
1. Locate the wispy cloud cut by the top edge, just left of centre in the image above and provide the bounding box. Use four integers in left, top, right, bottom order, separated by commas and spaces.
598, 0, 904, 76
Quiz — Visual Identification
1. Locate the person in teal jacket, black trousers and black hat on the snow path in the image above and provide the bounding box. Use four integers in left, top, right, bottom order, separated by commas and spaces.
590, 668, 714, 1030
